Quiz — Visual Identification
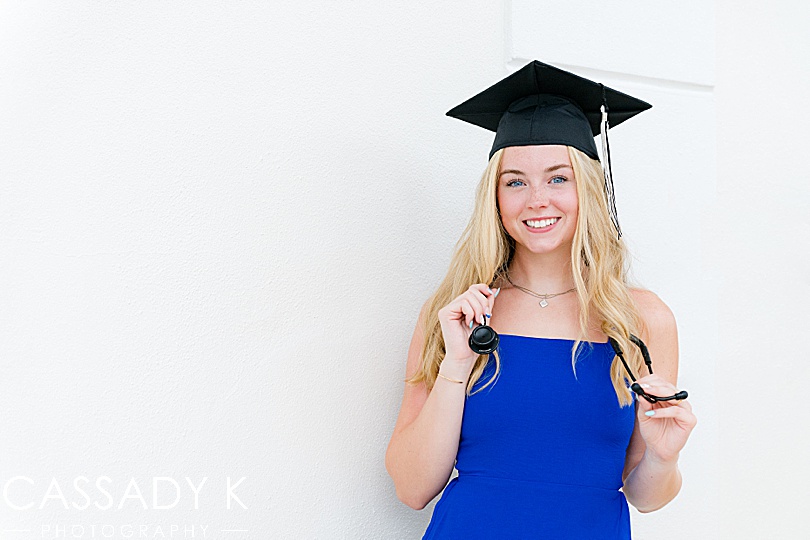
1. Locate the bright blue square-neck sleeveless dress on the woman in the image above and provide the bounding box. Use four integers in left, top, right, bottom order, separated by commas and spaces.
423, 334, 635, 540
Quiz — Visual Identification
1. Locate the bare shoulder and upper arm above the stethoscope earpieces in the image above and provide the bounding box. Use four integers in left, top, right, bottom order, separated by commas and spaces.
630, 289, 678, 384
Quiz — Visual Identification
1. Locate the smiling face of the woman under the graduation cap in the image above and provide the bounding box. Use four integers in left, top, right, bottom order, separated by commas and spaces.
498, 145, 578, 254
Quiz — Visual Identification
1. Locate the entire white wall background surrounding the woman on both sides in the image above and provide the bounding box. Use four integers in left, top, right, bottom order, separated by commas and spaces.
0, 0, 810, 540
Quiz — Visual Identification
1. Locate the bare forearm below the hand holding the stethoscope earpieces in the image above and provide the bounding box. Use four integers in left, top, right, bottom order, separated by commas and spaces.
623, 452, 681, 512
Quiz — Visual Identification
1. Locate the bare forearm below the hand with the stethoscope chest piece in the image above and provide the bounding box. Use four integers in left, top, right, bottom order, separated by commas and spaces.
385, 366, 469, 509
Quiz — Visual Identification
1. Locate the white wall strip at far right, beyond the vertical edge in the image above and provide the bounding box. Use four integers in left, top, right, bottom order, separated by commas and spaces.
706, 0, 810, 539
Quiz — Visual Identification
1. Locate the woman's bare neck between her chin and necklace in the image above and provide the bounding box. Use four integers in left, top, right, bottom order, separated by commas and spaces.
509, 246, 574, 294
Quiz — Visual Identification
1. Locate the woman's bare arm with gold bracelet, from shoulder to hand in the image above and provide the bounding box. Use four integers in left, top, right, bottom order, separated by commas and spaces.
385, 285, 491, 510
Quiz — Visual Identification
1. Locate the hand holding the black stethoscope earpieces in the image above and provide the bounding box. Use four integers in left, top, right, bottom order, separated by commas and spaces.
636, 375, 697, 461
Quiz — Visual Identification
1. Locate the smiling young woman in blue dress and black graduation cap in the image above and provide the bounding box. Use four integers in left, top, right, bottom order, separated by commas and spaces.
386, 61, 696, 539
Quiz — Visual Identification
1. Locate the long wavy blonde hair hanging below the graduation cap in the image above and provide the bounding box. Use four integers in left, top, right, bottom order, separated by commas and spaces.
408, 147, 643, 405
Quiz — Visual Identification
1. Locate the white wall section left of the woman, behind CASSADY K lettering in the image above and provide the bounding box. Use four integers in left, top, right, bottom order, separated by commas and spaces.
0, 0, 505, 539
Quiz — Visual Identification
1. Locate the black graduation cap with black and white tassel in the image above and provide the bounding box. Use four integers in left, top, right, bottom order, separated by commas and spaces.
447, 60, 652, 237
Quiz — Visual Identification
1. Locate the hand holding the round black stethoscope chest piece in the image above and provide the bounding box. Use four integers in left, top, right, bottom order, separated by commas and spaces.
439, 283, 500, 370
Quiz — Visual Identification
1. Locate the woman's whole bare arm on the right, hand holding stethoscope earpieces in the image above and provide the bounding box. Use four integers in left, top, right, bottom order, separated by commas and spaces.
624, 291, 697, 512
